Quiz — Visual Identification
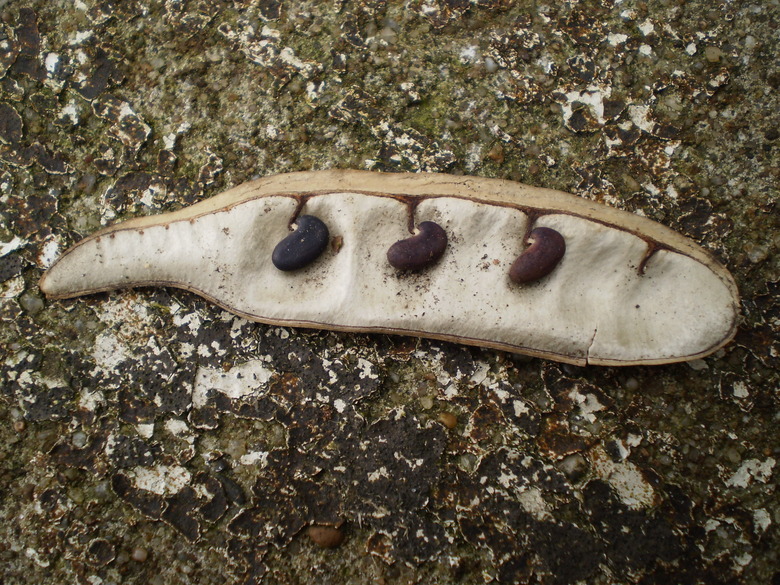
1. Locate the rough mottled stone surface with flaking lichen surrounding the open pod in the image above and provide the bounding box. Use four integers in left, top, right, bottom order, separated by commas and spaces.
0, 0, 780, 585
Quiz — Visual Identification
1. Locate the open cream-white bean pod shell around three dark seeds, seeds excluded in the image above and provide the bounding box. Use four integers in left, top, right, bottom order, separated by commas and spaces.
40, 171, 739, 365
